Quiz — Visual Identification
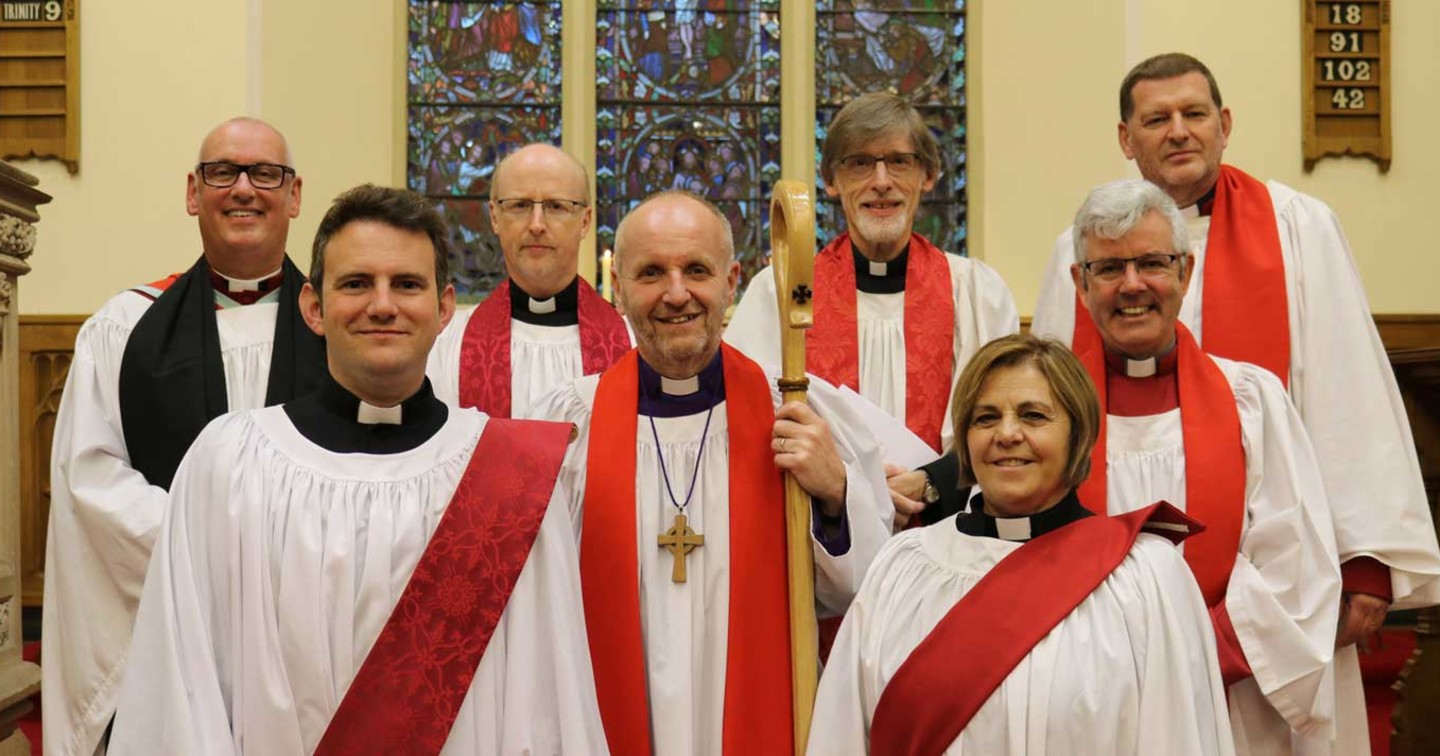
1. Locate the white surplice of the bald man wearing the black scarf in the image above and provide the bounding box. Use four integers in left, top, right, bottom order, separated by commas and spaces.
40, 291, 279, 756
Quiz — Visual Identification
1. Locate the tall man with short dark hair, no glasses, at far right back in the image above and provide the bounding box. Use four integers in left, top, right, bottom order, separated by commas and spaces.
1032, 53, 1440, 755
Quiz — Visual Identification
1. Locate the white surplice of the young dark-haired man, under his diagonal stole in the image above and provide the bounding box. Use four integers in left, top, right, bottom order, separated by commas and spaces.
111, 408, 605, 756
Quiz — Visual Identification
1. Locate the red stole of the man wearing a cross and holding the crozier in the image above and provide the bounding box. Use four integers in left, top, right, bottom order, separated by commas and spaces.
580, 344, 793, 756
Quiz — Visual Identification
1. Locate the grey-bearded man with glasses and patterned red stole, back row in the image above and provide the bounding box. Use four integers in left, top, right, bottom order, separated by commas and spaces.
726, 92, 1020, 524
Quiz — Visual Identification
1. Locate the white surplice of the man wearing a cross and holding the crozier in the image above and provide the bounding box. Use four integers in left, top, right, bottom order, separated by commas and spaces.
530, 376, 915, 756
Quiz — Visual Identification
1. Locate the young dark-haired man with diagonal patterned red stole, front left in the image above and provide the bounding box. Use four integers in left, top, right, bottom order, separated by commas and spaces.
111, 184, 605, 756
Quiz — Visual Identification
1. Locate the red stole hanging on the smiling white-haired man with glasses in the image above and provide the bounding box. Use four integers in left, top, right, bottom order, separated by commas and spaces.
1077, 323, 1246, 606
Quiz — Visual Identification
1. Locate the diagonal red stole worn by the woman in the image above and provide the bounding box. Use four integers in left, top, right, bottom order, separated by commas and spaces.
870, 500, 1204, 756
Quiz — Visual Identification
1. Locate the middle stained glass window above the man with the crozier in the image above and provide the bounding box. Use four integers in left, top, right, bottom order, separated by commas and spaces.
595, 0, 780, 292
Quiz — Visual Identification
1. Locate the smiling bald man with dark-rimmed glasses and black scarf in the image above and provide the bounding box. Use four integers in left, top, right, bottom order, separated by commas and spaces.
42, 118, 325, 753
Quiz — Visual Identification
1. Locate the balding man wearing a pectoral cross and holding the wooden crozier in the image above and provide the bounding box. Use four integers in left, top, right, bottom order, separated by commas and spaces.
531, 192, 926, 755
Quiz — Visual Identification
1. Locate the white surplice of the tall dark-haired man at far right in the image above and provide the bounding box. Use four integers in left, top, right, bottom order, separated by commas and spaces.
1031, 181, 1440, 756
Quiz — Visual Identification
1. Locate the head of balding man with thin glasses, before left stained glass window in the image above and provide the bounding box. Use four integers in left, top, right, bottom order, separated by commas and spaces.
490, 144, 592, 300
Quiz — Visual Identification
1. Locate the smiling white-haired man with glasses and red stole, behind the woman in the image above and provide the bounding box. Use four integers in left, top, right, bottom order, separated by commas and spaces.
1070, 179, 1341, 755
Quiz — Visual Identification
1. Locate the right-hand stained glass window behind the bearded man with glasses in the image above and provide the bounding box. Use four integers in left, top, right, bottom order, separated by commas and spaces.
815, 0, 966, 255
